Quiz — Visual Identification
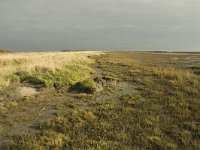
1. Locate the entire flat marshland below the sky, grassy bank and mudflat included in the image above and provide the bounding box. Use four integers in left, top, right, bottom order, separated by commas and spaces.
0, 51, 200, 150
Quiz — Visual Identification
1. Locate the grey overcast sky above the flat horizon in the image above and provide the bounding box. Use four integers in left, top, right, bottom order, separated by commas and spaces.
0, 0, 200, 51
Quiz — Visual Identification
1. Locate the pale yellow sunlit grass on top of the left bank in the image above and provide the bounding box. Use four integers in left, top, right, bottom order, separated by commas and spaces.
0, 51, 100, 87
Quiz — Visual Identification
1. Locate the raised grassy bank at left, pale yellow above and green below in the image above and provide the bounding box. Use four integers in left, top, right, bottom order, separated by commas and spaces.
0, 52, 98, 88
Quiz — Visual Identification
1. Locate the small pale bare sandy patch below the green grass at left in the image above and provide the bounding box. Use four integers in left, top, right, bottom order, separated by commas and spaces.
18, 87, 39, 97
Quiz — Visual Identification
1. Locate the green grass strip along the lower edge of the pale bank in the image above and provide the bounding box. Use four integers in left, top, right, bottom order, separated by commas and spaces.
8, 64, 92, 88
